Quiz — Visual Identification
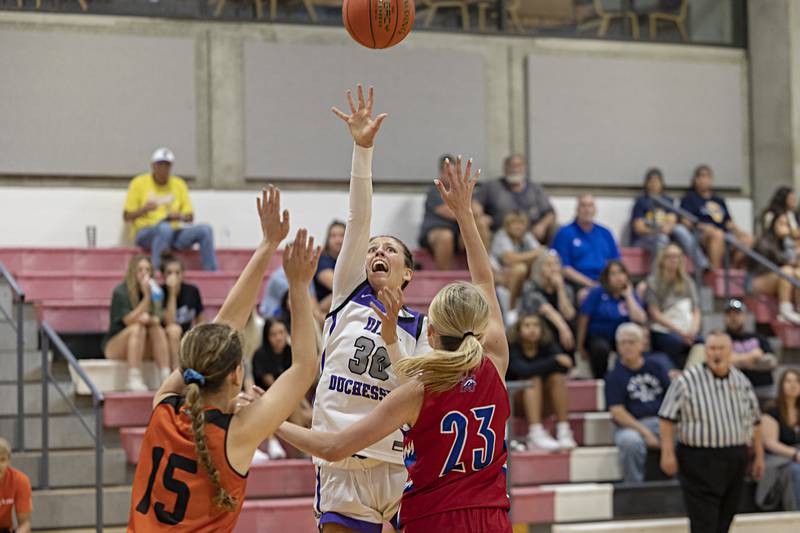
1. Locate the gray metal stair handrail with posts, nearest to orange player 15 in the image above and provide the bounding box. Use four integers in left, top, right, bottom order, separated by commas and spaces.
39, 322, 105, 533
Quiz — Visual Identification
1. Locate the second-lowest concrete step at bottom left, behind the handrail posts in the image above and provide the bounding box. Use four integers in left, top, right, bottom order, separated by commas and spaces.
14, 448, 128, 489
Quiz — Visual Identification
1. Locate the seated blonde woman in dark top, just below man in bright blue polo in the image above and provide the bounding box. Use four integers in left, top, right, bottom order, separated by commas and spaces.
518, 250, 576, 354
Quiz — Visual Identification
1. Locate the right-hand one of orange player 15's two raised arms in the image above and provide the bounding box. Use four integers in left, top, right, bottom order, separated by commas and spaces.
229, 229, 321, 456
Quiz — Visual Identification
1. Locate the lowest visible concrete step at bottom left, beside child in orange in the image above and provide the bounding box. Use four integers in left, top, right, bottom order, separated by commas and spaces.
32, 486, 131, 530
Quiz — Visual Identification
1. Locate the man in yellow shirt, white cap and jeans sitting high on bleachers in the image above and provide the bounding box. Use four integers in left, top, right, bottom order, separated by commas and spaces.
123, 148, 217, 270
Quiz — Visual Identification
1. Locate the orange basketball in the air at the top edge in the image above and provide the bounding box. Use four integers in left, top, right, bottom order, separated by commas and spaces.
342, 0, 414, 48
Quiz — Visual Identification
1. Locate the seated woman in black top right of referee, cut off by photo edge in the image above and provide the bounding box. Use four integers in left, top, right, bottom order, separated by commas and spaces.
756, 369, 800, 511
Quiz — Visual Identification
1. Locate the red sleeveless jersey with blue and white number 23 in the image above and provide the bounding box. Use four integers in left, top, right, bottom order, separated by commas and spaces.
400, 357, 510, 525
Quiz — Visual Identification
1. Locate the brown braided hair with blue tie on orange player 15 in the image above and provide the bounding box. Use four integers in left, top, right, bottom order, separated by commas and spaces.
180, 324, 242, 511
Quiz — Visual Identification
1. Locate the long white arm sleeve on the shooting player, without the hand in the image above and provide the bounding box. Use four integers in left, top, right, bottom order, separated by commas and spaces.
331, 144, 372, 309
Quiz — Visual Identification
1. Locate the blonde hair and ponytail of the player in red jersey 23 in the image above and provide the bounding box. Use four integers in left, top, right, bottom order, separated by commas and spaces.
395, 282, 489, 392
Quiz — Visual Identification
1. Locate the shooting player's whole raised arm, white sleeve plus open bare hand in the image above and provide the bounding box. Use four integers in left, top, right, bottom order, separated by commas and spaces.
331, 84, 386, 309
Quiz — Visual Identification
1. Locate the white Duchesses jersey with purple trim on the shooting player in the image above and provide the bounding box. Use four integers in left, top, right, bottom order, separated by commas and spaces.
311, 280, 430, 468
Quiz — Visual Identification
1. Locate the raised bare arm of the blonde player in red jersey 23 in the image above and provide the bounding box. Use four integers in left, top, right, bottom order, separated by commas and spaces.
435, 156, 508, 376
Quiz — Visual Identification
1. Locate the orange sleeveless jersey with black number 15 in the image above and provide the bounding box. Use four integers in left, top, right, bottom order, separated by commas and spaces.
128, 396, 247, 533
